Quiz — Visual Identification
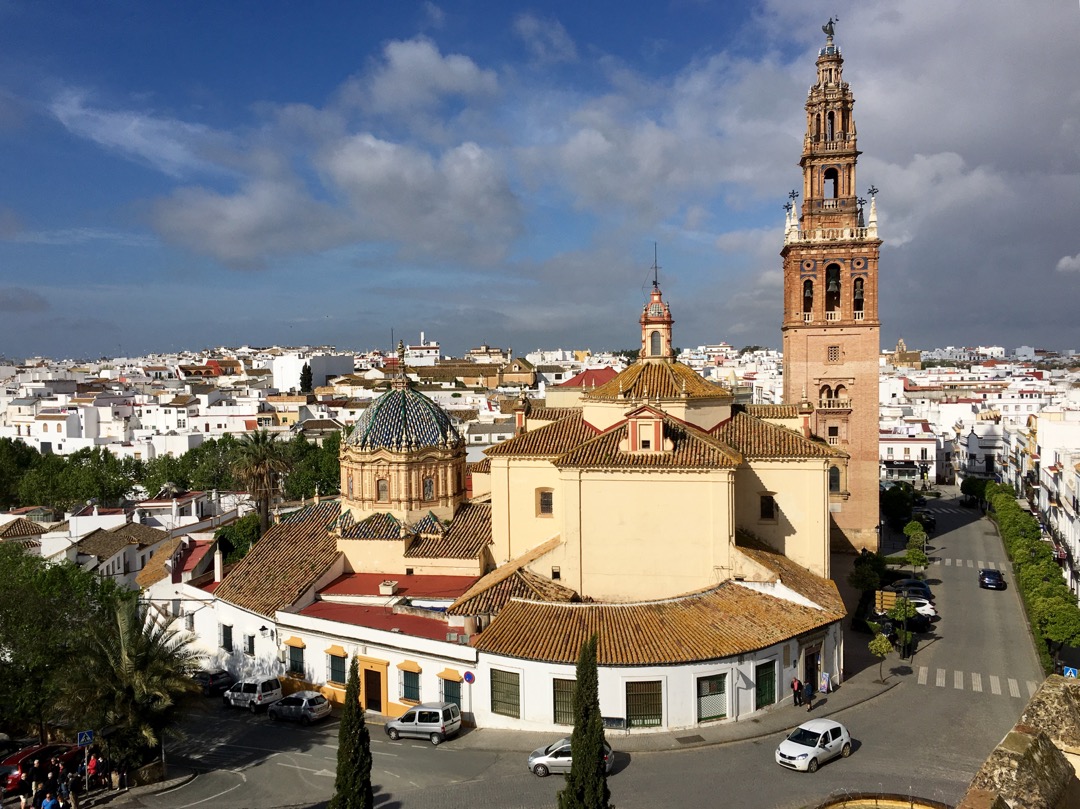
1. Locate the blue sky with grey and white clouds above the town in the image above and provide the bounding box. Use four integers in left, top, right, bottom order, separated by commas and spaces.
0, 0, 1080, 359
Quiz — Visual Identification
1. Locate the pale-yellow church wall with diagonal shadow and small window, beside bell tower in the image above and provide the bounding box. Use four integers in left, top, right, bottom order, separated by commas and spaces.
734, 459, 829, 578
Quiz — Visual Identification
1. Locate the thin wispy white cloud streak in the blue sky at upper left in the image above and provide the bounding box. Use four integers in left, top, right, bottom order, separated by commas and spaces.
50, 90, 219, 177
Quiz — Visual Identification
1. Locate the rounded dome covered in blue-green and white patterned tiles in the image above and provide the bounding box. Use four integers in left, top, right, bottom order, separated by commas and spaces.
348, 386, 464, 450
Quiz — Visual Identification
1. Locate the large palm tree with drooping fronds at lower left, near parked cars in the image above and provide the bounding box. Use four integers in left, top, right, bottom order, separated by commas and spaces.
63, 597, 199, 766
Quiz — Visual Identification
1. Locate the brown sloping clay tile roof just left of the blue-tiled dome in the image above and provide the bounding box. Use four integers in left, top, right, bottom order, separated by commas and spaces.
214, 501, 341, 618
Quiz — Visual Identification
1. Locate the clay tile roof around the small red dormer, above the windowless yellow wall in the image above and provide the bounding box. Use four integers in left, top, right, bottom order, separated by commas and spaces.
554, 416, 742, 469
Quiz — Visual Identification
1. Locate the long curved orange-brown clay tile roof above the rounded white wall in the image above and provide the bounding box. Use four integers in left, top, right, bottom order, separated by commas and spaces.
473, 581, 838, 665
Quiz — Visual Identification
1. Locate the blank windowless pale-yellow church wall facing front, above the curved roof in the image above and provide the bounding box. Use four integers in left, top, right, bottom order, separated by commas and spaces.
565, 470, 733, 601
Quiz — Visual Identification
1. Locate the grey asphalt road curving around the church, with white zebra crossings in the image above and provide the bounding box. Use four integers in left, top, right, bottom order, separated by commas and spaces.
110, 486, 1042, 809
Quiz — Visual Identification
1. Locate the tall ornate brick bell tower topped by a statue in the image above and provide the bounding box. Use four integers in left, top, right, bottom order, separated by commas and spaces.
780, 19, 881, 551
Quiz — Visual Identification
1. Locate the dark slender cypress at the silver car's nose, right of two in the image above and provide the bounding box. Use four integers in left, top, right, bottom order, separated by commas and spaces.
558, 633, 611, 809
